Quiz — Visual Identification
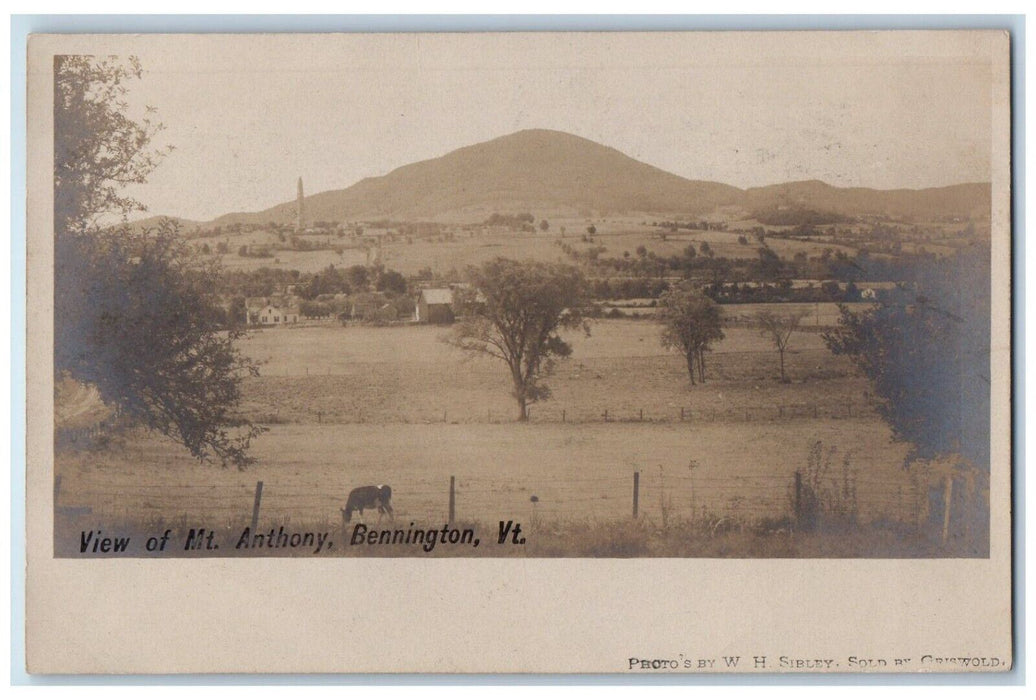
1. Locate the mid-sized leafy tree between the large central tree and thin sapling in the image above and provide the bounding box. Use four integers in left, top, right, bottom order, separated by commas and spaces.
659, 287, 723, 385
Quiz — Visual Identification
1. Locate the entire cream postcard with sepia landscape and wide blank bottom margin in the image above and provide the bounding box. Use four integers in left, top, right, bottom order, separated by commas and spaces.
26, 31, 1012, 673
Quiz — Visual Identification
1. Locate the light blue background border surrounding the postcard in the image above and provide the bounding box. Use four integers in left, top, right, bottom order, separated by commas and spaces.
10, 14, 1026, 686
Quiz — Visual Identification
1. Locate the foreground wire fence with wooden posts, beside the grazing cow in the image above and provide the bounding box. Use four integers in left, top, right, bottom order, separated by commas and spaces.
55, 455, 939, 527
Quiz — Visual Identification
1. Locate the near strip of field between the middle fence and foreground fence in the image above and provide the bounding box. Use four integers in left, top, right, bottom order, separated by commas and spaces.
58, 418, 917, 527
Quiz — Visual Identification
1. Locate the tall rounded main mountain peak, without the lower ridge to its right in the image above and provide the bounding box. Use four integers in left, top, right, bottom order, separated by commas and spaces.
213, 129, 741, 225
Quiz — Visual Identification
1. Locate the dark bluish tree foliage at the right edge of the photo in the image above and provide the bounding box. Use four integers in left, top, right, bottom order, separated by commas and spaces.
825, 246, 990, 469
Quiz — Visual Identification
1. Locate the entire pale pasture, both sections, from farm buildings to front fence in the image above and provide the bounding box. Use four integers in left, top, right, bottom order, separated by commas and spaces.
56, 320, 940, 554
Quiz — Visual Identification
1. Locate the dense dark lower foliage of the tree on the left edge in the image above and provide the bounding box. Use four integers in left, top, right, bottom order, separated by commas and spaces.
55, 221, 261, 466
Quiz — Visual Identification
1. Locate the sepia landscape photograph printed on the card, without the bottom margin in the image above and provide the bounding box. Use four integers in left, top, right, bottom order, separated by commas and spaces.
46, 34, 1007, 559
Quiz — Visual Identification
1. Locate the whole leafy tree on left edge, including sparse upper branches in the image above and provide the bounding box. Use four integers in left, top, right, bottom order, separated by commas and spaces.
54, 56, 262, 466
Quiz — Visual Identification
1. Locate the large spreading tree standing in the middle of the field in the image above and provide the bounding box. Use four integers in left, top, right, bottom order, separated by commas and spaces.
450, 258, 589, 420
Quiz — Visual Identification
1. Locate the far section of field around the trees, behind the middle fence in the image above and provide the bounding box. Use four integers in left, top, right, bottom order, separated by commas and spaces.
233, 320, 869, 424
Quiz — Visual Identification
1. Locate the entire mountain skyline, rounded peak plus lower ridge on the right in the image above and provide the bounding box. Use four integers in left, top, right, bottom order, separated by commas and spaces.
195, 129, 990, 226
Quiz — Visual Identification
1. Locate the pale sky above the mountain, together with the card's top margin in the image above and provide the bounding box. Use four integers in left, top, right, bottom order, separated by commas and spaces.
98, 32, 991, 221
